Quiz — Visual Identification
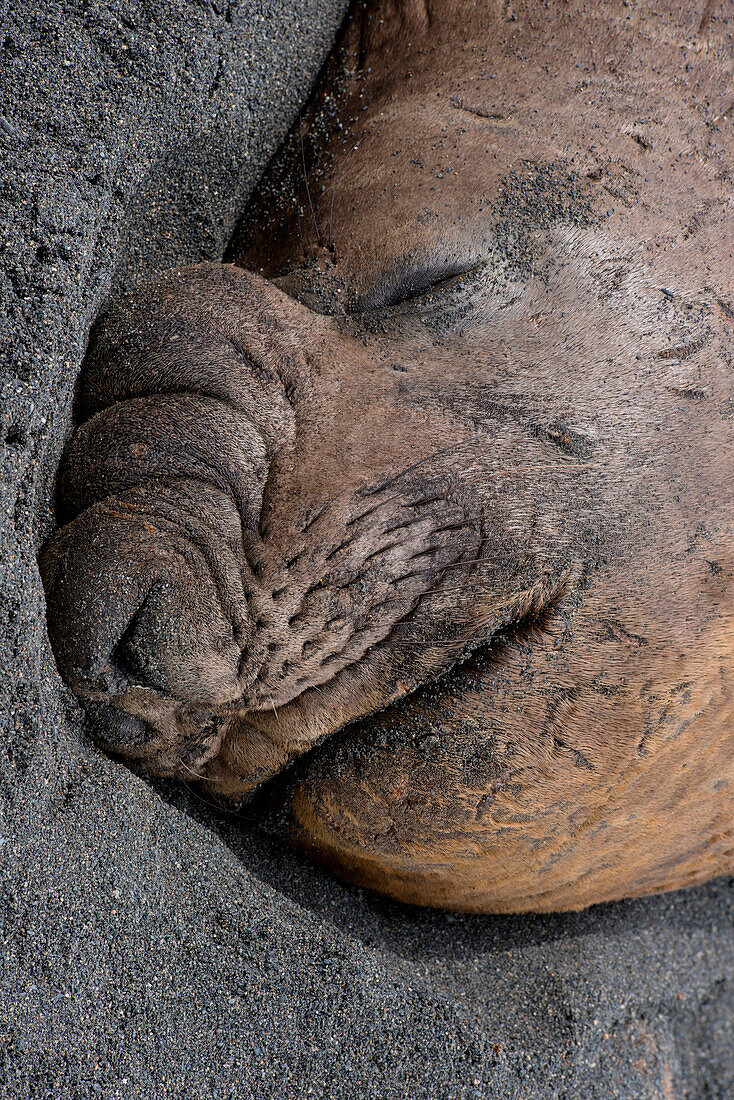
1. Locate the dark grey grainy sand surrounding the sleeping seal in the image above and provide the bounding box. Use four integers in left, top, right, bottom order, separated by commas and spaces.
0, 0, 734, 1100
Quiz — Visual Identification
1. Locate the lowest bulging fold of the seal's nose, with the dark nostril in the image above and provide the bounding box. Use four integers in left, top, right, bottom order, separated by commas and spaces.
41, 480, 250, 705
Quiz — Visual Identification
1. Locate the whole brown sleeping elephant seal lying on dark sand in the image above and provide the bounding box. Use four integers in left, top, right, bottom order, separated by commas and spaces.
41, 0, 734, 912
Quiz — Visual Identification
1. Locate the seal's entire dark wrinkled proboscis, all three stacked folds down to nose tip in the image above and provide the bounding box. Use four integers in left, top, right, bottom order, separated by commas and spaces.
40, 267, 308, 755
